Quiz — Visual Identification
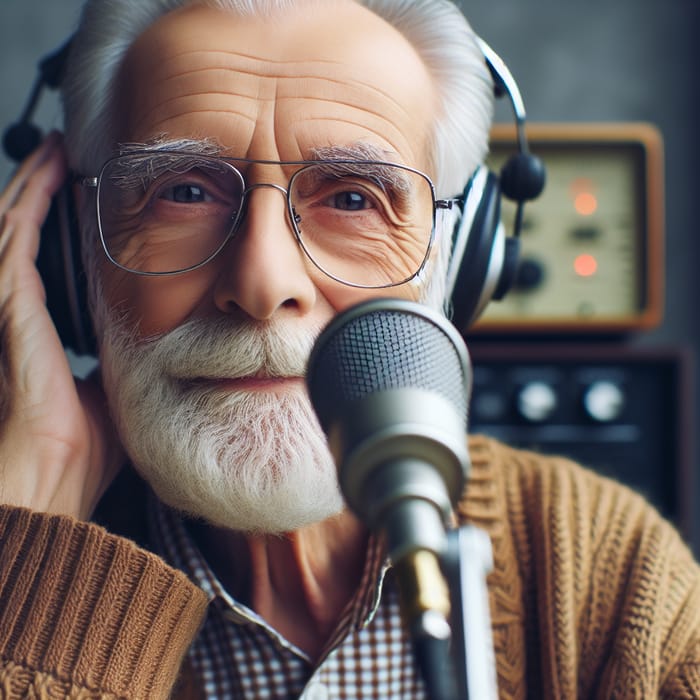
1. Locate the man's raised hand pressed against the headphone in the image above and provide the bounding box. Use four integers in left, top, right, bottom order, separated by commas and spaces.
0, 134, 121, 518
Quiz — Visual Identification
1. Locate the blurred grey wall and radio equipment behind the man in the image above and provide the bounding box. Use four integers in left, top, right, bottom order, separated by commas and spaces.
0, 0, 700, 554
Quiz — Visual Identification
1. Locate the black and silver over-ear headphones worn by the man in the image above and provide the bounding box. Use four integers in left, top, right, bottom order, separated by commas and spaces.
3, 34, 545, 354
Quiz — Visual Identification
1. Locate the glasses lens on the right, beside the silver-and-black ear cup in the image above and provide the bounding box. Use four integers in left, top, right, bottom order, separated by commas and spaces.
289, 162, 434, 287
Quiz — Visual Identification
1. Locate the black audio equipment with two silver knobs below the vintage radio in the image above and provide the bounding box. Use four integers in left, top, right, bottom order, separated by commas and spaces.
469, 342, 693, 536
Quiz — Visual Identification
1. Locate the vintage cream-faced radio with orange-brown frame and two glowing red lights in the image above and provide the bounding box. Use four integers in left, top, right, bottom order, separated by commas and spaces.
470, 123, 664, 334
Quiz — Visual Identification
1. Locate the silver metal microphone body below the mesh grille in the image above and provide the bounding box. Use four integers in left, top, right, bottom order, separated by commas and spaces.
328, 387, 468, 562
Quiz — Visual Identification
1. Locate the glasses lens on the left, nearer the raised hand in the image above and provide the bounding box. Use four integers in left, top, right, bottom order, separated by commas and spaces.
98, 152, 244, 274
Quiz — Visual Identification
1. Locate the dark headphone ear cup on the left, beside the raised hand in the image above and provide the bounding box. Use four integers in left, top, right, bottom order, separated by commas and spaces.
36, 186, 96, 355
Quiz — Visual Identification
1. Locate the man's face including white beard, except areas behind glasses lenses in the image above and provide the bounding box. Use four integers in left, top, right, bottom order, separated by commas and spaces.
95, 0, 434, 532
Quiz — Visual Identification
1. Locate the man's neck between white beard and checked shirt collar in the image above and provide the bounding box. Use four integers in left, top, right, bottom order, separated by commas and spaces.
189, 511, 367, 659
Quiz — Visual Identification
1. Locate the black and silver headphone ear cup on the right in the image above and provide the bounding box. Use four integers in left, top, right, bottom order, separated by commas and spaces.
448, 167, 505, 330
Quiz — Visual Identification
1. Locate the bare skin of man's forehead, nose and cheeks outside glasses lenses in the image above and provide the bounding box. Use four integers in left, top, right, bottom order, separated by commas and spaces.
103, 0, 434, 336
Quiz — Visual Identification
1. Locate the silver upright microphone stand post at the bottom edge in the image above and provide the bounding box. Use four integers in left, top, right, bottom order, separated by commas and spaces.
441, 525, 498, 700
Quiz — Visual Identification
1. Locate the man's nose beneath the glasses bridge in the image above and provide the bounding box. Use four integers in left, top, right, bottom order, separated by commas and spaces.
214, 183, 317, 320
